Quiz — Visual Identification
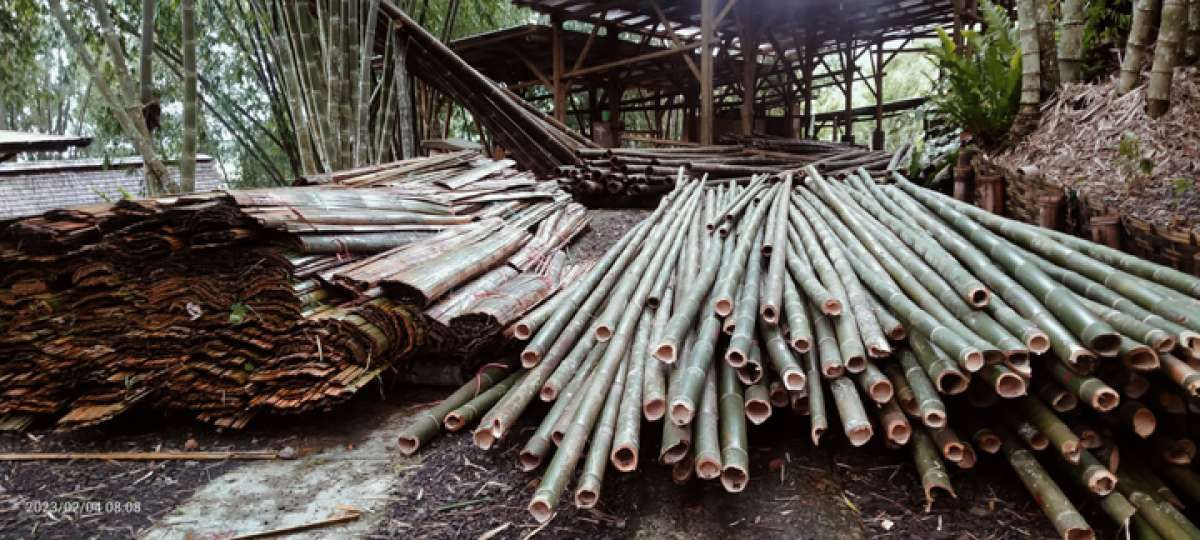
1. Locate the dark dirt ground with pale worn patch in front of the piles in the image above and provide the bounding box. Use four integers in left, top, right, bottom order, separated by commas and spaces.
0, 210, 1070, 539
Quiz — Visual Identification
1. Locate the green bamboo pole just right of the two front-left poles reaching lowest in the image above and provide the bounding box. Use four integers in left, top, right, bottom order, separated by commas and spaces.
610, 310, 661, 473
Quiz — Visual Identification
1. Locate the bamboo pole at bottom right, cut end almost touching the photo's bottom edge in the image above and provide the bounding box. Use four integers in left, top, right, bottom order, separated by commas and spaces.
997, 430, 1094, 540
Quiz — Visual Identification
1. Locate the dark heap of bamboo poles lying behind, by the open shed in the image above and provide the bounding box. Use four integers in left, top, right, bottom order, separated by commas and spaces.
558, 137, 905, 202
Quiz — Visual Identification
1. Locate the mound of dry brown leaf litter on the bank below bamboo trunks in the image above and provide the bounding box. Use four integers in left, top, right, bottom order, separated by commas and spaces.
1000, 67, 1200, 233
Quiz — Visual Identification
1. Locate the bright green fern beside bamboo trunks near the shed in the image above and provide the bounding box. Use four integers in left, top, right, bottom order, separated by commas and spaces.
929, 0, 1021, 148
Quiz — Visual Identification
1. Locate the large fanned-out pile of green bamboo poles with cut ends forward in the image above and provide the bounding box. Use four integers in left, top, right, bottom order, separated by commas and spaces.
400, 167, 1200, 539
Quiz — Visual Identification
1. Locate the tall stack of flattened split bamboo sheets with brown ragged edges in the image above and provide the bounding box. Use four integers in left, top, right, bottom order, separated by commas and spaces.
0, 156, 587, 428
